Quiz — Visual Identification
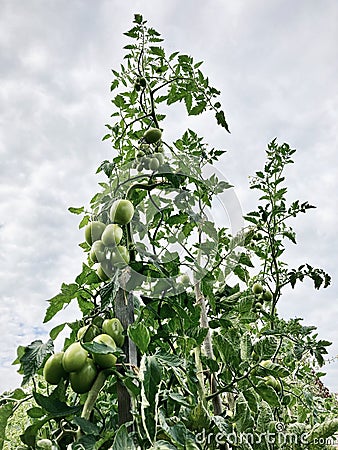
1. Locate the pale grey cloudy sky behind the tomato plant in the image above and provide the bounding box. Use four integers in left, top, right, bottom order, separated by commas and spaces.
0, 0, 338, 391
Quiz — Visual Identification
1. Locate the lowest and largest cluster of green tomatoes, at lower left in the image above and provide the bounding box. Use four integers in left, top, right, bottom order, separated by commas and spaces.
43, 317, 124, 394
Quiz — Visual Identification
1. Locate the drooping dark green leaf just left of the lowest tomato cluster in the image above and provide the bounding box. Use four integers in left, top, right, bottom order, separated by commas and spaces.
20, 339, 54, 385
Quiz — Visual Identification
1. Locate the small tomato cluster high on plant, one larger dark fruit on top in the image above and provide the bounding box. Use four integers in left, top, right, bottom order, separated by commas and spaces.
135, 128, 165, 172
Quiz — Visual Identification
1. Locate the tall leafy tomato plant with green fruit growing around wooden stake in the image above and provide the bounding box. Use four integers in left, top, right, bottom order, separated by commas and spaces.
0, 15, 338, 450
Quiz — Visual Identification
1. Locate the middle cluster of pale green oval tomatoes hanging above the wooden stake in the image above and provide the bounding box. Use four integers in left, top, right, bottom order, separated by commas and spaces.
85, 199, 134, 281
